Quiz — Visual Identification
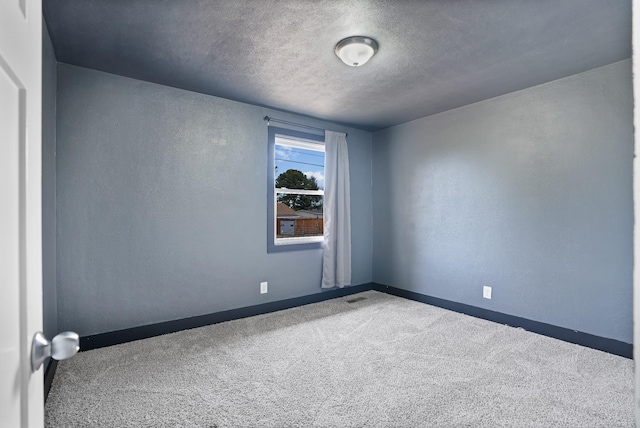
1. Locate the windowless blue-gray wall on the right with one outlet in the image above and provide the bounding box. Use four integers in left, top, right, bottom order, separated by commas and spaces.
373, 60, 633, 343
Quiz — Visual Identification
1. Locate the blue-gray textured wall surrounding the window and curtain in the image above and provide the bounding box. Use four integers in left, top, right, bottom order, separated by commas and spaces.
57, 64, 373, 335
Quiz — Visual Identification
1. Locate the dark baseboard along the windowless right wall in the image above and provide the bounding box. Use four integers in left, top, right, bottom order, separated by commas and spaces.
373, 283, 633, 358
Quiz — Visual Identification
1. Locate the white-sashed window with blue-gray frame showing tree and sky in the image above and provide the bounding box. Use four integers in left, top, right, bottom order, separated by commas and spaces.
267, 127, 325, 252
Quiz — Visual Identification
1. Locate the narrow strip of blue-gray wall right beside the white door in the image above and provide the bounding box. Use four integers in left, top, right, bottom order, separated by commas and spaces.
42, 20, 58, 339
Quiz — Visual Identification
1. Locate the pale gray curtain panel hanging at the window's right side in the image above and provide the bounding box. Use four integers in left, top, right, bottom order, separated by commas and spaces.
322, 131, 351, 288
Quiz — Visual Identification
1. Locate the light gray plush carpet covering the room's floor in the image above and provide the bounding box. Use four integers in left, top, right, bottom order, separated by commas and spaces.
45, 291, 634, 428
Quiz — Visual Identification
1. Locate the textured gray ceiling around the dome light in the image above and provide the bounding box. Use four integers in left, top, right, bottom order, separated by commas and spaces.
44, 0, 631, 130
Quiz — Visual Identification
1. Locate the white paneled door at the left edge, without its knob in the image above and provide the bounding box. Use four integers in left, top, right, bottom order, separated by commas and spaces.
0, 0, 44, 428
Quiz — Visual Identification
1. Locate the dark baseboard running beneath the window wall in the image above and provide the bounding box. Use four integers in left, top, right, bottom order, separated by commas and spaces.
80, 283, 373, 351
